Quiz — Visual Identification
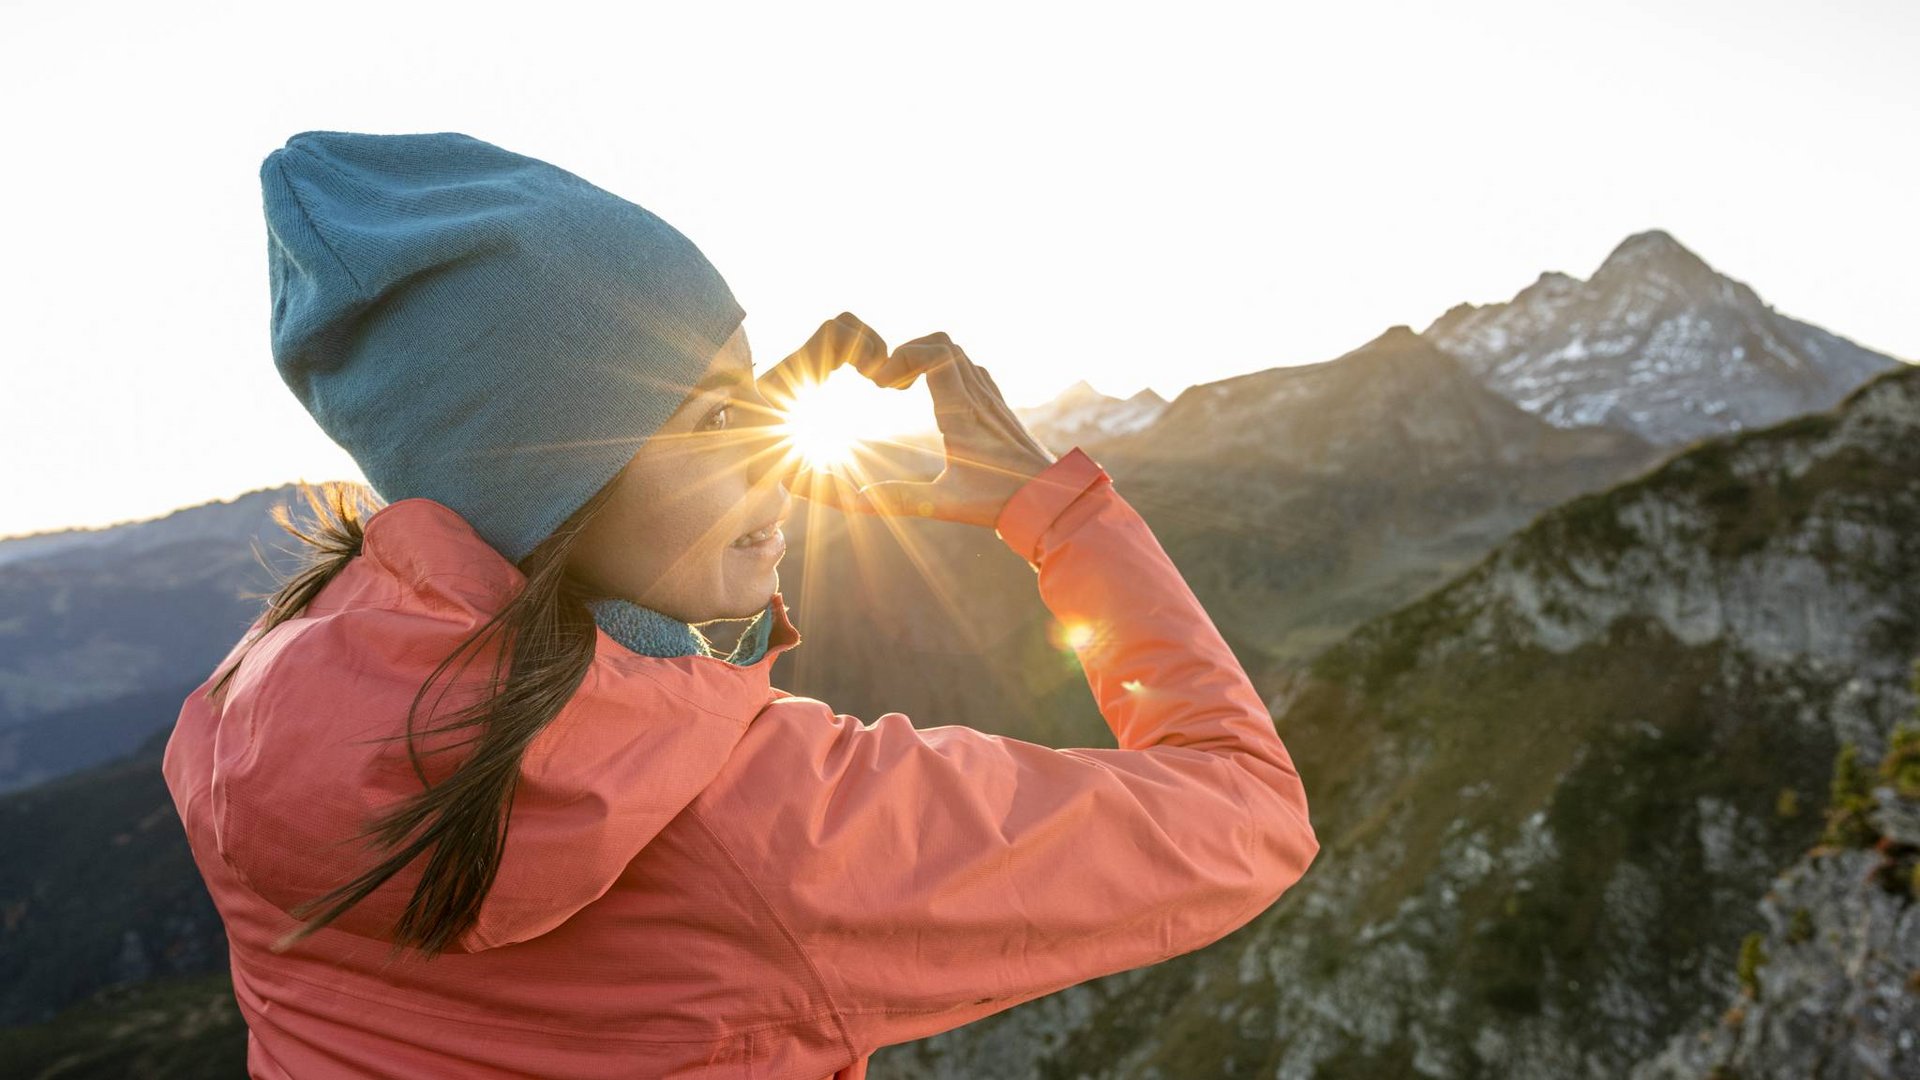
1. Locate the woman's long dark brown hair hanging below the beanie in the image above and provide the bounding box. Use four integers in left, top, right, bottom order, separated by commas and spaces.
209, 474, 612, 957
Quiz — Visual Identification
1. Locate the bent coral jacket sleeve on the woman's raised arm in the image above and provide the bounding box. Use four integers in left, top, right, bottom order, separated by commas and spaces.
708, 448, 1319, 1053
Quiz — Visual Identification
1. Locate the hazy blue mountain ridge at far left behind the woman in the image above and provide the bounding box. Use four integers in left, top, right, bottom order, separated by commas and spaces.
0, 486, 294, 792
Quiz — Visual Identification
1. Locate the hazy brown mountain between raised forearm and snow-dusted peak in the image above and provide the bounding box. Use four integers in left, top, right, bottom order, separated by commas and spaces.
1100, 327, 1659, 663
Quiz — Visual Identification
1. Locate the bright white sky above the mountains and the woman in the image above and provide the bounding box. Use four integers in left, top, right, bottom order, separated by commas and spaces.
0, 0, 1920, 536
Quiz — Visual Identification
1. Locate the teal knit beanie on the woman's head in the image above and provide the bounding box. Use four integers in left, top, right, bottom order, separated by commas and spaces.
259, 131, 745, 563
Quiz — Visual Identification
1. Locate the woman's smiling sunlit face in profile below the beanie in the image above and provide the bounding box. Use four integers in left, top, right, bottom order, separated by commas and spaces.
566, 322, 793, 623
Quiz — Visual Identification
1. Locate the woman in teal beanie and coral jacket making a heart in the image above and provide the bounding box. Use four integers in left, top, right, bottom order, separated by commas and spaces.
165, 131, 1319, 1080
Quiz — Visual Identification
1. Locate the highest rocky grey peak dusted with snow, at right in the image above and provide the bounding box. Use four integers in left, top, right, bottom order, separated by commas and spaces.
1423, 229, 1901, 446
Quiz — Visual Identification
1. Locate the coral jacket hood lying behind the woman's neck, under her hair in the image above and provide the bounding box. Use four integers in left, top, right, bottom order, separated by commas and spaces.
202, 498, 801, 951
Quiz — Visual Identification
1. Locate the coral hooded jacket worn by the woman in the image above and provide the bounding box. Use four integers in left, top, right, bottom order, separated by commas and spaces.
165, 448, 1319, 1080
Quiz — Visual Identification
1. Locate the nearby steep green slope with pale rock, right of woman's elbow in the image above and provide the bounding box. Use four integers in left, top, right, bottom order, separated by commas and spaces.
874, 353, 1920, 1080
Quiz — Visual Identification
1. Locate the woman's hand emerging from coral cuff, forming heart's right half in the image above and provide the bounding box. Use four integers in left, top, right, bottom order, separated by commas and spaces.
795, 328, 1056, 528
